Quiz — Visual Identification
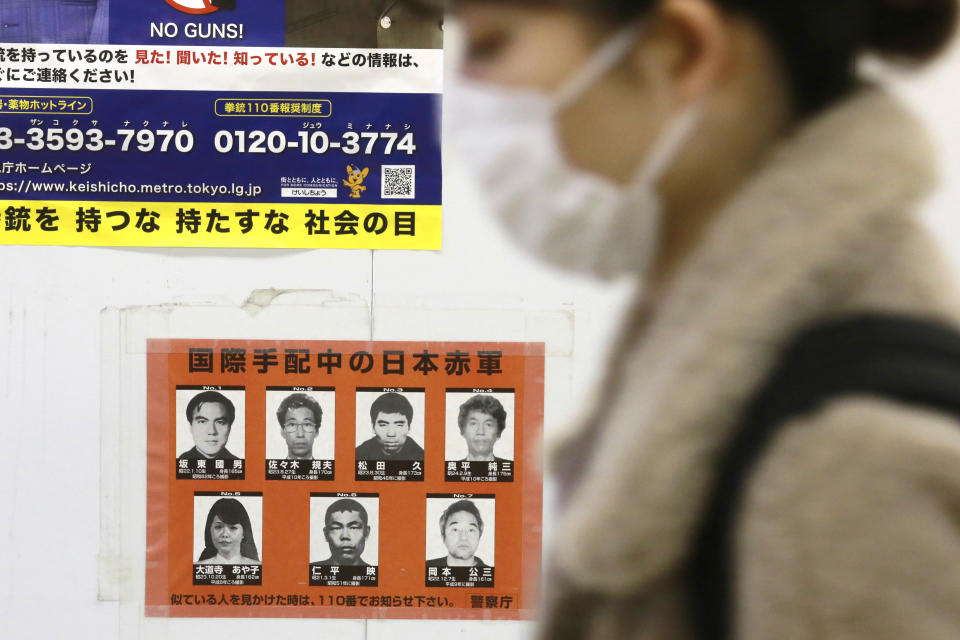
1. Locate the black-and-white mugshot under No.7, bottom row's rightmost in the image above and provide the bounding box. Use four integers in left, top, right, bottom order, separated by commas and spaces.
427, 498, 494, 567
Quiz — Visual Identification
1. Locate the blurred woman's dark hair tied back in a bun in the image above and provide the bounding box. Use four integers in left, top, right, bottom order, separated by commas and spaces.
459, 0, 957, 117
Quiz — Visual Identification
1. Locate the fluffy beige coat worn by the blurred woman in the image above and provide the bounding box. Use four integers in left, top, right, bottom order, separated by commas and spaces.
542, 89, 960, 640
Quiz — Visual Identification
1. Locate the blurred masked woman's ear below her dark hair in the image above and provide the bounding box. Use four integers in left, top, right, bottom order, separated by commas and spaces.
634, 0, 730, 104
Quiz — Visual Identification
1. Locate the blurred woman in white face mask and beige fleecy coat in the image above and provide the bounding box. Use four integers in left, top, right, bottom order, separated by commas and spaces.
449, 0, 960, 640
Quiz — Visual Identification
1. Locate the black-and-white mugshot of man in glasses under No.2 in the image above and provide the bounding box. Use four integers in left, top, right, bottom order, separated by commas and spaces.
265, 388, 336, 461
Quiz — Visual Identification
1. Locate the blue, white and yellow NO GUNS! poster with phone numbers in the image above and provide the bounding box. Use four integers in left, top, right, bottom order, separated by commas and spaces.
0, 0, 443, 249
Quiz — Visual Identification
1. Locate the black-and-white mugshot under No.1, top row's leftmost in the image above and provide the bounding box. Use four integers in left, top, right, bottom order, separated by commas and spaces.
177, 389, 244, 461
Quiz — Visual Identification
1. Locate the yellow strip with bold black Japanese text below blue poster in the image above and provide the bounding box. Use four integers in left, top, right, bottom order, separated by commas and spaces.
0, 200, 441, 250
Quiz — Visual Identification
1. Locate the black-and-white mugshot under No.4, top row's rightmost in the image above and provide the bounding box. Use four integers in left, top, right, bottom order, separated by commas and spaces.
444, 391, 514, 462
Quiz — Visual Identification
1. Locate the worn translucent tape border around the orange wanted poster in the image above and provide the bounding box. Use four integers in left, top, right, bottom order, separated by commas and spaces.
98, 291, 574, 638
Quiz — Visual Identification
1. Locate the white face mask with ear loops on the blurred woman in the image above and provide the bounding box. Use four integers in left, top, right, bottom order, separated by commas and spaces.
449, 26, 700, 278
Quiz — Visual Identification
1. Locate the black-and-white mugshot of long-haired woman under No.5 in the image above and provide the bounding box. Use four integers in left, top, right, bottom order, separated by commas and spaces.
193, 493, 263, 565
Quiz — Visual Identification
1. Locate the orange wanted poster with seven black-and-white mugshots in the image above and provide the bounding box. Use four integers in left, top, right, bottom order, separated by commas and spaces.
146, 340, 544, 620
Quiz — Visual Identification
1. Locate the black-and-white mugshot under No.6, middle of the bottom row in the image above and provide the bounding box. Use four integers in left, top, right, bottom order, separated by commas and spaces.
310, 496, 378, 567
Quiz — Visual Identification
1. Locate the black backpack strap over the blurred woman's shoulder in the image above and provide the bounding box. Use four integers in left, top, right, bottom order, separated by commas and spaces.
686, 315, 960, 640
